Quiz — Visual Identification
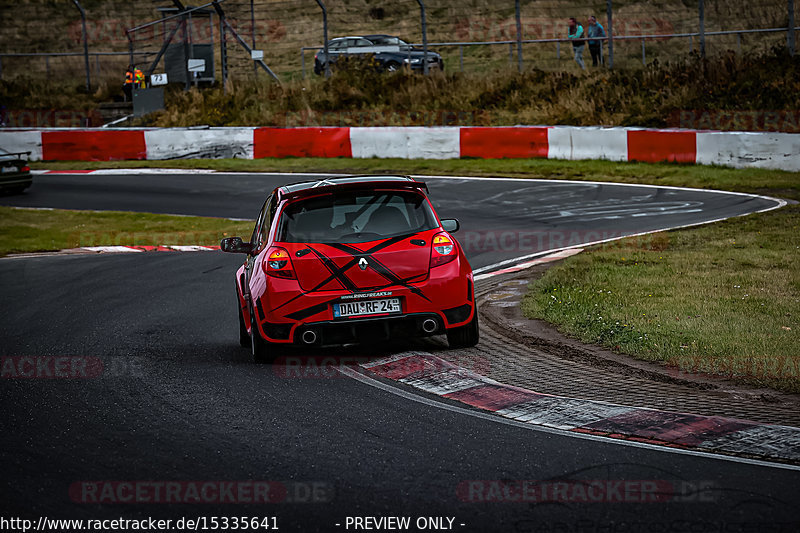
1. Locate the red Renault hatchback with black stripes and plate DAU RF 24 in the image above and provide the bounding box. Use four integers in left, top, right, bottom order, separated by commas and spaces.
220, 176, 478, 362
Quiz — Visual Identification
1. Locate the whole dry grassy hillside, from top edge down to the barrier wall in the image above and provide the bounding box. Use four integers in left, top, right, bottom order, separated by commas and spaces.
0, 0, 800, 132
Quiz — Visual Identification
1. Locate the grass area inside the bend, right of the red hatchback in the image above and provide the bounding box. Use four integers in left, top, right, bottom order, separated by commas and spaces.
522, 205, 800, 393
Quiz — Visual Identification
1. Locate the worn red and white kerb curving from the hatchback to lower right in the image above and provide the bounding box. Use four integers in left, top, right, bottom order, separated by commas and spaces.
360, 352, 800, 463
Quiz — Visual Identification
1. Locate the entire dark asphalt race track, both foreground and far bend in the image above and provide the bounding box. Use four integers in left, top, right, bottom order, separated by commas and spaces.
0, 174, 800, 532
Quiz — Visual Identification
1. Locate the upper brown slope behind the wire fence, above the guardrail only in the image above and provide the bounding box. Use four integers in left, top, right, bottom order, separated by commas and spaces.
0, 0, 800, 83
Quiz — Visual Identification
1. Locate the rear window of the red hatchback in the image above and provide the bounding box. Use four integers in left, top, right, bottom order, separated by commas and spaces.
278, 191, 437, 243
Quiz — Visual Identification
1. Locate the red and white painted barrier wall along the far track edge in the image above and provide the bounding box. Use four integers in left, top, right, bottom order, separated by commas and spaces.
0, 126, 800, 171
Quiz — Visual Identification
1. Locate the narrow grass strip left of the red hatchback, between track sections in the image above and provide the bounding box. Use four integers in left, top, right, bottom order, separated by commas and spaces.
0, 207, 253, 256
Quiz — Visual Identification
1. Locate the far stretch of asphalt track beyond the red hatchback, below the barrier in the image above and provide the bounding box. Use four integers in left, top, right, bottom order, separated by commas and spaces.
0, 171, 776, 269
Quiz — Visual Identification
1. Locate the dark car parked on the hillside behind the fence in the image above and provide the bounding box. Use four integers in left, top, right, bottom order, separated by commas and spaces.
314, 34, 444, 74
